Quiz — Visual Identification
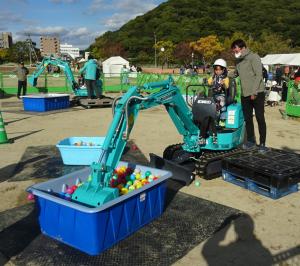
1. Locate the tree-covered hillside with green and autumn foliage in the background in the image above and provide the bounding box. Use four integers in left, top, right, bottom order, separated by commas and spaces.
88, 0, 300, 64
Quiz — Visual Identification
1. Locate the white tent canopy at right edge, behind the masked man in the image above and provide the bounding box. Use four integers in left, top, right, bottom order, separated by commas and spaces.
261, 53, 300, 66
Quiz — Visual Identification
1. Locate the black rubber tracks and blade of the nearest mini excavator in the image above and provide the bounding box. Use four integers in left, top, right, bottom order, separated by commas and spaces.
150, 143, 245, 185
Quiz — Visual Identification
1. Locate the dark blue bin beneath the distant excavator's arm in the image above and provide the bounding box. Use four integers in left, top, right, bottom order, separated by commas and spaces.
22, 93, 70, 112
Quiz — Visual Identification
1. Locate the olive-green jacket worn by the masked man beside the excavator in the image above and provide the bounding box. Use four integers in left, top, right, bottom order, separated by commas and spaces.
236, 49, 265, 97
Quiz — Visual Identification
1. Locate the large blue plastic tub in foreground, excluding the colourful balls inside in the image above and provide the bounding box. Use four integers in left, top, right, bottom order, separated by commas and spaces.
27, 162, 171, 255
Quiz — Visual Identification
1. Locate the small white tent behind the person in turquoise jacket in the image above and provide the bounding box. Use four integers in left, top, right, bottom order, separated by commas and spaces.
102, 56, 129, 77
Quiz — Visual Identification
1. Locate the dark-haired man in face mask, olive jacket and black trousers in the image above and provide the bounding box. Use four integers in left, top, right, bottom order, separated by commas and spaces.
231, 39, 268, 152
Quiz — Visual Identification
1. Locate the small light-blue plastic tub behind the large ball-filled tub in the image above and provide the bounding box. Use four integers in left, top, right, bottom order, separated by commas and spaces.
56, 137, 105, 165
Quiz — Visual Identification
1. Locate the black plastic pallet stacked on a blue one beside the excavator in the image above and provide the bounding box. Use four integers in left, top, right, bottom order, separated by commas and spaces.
222, 149, 300, 199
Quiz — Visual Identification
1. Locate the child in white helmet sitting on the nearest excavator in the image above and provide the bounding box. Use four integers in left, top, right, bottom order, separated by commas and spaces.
200, 58, 229, 144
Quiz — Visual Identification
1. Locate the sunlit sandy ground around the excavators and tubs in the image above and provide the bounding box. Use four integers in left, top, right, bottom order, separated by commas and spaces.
0, 95, 300, 265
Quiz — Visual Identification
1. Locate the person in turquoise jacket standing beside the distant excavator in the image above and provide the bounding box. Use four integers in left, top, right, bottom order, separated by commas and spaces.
79, 55, 101, 99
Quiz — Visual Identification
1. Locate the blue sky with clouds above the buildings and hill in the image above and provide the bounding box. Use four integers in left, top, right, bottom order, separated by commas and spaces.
0, 0, 166, 49
